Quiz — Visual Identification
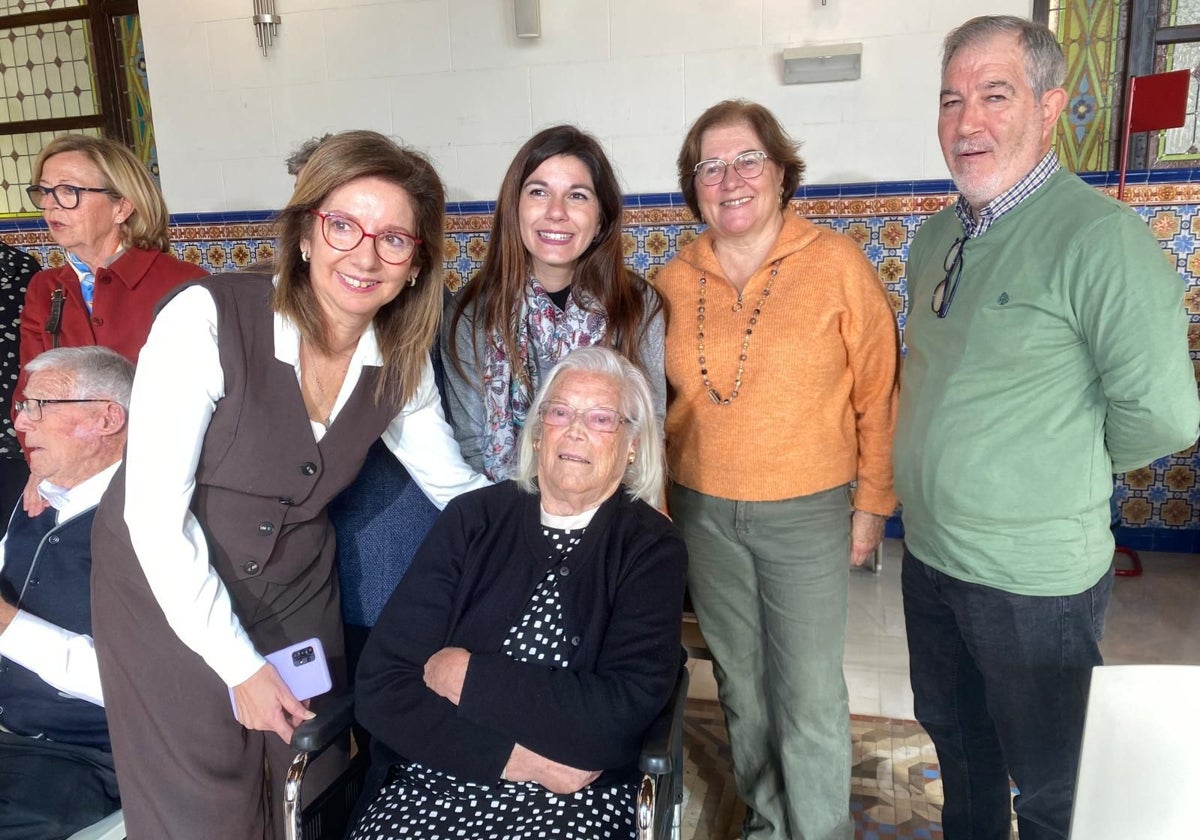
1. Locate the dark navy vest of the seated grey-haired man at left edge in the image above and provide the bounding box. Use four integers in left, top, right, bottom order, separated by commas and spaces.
0, 508, 112, 750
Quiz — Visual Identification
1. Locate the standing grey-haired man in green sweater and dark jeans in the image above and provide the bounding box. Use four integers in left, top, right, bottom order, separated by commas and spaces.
894, 17, 1200, 840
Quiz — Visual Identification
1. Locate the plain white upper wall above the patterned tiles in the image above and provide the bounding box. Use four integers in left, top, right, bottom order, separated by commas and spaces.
139, 0, 1032, 212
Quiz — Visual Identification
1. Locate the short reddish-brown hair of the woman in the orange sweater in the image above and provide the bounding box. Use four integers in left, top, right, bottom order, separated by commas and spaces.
676, 100, 804, 218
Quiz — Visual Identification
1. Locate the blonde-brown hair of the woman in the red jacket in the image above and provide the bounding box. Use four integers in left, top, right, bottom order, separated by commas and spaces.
32, 134, 170, 251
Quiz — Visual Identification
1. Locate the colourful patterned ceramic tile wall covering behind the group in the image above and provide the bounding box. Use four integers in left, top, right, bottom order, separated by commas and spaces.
0, 169, 1200, 552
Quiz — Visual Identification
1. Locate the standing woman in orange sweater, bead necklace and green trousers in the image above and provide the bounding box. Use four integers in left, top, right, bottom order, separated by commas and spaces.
656, 101, 899, 840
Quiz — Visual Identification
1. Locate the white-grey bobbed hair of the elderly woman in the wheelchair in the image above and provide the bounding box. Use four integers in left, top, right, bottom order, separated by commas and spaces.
514, 347, 666, 508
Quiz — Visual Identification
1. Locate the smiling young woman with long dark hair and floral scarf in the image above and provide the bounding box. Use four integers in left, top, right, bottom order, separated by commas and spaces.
443, 125, 666, 481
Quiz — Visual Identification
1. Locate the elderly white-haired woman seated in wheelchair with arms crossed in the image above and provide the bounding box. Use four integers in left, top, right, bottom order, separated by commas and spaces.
353, 348, 686, 840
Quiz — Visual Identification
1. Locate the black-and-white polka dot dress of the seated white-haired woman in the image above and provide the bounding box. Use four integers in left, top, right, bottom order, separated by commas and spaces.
354, 526, 637, 840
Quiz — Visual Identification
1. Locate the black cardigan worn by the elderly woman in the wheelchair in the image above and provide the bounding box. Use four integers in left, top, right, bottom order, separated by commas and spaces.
356, 481, 688, 784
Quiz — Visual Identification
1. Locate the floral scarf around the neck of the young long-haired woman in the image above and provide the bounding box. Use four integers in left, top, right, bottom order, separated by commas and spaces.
482, 277, 606, 481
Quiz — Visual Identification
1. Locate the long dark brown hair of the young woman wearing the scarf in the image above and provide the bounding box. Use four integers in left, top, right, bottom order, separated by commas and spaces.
449, 125, 662, 385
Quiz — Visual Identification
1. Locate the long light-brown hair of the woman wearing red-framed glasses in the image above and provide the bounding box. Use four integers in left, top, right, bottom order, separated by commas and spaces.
272, 131, 445, 409
